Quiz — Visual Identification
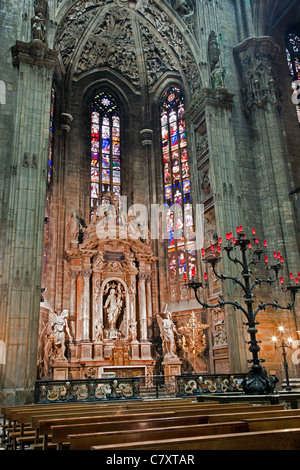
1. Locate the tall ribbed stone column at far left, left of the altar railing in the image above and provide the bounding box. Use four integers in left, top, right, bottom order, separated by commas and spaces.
0, 40, 57, 404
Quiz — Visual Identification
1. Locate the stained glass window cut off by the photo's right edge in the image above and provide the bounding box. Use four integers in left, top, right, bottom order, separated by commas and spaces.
286, 28, 300, 122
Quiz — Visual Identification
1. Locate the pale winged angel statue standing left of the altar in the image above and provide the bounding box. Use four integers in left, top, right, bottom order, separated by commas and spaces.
48, 309, 73, 359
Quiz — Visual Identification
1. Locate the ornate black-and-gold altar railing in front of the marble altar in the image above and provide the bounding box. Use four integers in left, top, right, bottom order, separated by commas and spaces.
35, 374, 244, 403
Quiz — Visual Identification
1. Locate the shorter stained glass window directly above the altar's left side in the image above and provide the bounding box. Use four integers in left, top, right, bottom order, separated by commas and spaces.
91, 91, 121, 212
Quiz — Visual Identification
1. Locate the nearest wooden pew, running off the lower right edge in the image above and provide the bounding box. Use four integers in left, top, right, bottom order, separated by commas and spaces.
91, 428, 300, 451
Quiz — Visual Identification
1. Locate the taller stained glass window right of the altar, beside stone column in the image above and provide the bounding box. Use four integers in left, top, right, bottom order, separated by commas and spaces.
160, 87, 196, 300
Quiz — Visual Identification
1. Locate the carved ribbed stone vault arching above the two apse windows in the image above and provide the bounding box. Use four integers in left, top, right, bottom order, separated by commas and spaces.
55, 0, 203, 93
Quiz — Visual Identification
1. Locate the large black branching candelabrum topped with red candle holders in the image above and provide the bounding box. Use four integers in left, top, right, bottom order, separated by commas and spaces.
186, 226, 300, 395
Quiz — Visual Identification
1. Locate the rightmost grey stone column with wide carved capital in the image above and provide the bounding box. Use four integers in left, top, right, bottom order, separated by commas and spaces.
234, 36, 299, 273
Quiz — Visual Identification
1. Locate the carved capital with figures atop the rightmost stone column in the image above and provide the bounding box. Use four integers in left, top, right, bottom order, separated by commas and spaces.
234, 36, 281, 114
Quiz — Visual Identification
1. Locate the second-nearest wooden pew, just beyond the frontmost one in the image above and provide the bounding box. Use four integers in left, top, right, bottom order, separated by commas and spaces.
68, 422, 248, 450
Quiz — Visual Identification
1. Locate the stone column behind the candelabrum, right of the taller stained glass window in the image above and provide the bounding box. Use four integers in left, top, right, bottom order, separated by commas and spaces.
187, 86, 247, 372
